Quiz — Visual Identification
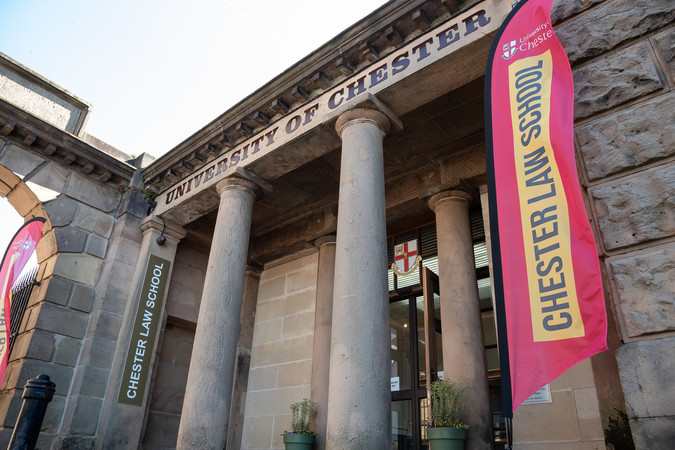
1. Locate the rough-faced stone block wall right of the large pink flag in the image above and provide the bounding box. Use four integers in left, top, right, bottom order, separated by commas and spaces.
554, 0, 675, 448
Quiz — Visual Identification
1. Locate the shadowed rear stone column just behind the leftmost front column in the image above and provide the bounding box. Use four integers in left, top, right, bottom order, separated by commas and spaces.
227, 264, 262, 448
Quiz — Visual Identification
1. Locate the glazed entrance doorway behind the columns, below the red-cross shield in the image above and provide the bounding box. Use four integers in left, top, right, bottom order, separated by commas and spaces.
388, 216, 505, 450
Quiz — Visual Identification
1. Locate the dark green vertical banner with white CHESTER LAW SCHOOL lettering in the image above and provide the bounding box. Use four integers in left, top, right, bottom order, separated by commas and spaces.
117, 255, 171, 406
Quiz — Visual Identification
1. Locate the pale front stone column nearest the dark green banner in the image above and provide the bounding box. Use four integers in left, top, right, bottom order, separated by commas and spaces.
176, 178, 258, 449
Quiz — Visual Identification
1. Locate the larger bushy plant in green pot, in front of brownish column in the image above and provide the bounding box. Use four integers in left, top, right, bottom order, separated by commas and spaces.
427, 380, 468, 450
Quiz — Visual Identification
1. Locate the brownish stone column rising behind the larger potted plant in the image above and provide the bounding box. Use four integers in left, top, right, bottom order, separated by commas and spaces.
429, 191, 493, 450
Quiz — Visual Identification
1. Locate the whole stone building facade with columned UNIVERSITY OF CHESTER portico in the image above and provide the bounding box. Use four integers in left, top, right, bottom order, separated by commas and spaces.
0, 0, 675, 449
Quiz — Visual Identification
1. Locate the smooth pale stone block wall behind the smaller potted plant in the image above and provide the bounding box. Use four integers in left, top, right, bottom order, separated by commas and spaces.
241, 253, 318, 450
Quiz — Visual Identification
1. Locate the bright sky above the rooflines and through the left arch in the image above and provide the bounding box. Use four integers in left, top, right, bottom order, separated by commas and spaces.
0, 0, 386, 258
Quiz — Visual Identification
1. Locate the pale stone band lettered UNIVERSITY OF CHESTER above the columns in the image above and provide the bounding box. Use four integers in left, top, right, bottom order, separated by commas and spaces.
149, 1, 508, 218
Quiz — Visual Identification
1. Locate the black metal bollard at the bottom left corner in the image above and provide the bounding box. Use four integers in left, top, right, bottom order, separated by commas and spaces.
7, 375, 56, 450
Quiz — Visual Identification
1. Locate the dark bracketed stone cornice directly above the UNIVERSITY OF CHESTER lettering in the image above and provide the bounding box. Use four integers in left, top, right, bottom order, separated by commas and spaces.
143, 0, 477, 192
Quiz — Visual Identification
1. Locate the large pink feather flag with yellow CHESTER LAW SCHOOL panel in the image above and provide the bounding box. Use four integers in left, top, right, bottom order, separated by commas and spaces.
485, 0, 607, 410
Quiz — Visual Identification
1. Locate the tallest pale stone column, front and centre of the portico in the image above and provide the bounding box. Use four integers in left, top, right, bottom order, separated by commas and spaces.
326, 109, 391, 450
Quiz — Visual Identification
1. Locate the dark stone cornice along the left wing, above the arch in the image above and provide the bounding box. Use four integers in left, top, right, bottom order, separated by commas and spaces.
0, 100, 136, 190
